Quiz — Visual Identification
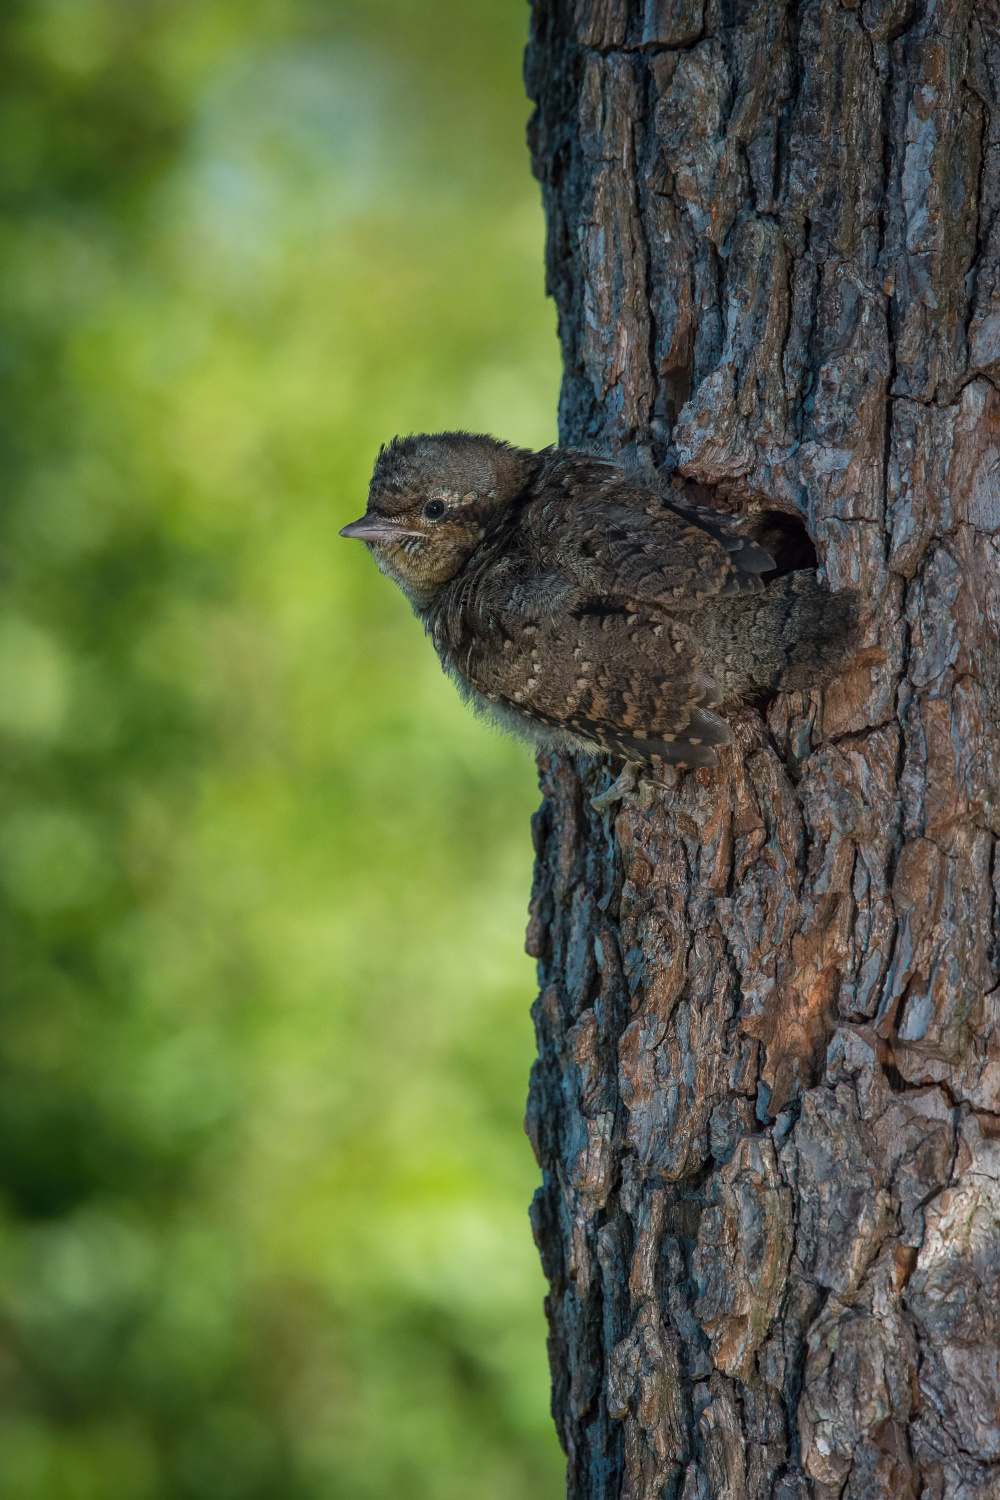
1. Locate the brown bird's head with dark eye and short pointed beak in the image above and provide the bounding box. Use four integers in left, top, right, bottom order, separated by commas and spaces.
340, 432, 541, 611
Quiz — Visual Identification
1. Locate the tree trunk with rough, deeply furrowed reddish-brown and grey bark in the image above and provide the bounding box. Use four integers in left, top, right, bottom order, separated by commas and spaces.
526, 0, 1000, 1500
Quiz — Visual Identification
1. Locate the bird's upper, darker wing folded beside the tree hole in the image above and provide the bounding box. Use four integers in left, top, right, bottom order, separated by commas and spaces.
528, 467, 774, 611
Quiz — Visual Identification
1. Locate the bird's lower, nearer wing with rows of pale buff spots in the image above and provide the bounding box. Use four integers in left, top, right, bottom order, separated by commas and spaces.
442, 600, 732, 765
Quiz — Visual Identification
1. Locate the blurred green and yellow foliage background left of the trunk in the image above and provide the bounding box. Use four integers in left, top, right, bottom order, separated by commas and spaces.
0, 0, 562, 1500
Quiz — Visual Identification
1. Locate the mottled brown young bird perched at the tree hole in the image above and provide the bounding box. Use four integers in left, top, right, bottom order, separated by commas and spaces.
340, 432, 858, 810
